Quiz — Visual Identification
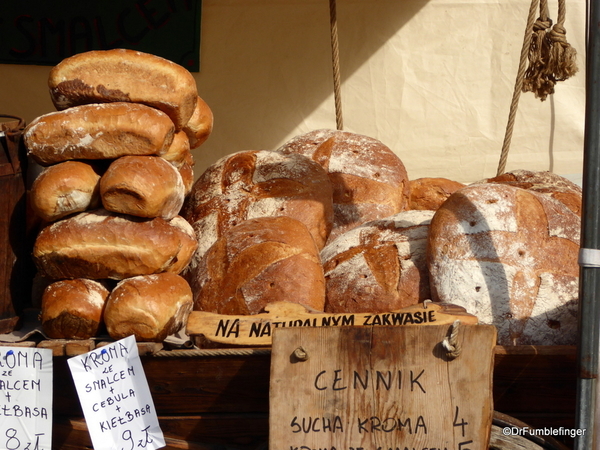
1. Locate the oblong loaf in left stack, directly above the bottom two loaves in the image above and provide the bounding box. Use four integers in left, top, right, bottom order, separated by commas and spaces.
33, 210, 182, 280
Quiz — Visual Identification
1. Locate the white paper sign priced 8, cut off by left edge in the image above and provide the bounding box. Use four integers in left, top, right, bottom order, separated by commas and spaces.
0, 347, 52, 450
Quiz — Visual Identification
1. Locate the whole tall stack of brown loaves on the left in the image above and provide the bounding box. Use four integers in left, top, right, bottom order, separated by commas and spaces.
24, 49, 213, 342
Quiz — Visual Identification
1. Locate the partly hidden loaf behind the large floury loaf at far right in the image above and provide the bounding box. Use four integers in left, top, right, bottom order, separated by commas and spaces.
483, 170, 583, 216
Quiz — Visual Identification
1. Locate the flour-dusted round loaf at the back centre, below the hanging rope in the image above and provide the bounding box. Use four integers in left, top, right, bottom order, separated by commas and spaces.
277, 129, 409, 241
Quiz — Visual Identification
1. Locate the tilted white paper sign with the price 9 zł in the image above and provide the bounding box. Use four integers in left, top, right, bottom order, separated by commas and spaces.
68, 336, 165, 450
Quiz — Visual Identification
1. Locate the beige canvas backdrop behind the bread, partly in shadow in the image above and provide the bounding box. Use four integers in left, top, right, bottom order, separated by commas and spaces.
0, 0, 586, 182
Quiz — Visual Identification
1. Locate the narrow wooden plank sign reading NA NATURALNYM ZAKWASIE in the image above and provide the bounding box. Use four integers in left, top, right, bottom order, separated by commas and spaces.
186, 302, 477, 347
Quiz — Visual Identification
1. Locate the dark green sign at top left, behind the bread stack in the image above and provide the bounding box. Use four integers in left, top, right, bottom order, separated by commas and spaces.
0, 0, 202, 72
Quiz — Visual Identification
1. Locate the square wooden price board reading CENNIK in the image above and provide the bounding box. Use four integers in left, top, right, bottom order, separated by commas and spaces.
269, 325, 496, 450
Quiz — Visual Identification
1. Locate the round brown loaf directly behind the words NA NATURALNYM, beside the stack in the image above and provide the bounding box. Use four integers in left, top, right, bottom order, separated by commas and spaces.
190, 216, 325, 314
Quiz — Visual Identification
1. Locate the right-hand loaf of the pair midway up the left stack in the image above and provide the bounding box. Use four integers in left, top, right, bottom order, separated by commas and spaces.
100, 156, 185, 220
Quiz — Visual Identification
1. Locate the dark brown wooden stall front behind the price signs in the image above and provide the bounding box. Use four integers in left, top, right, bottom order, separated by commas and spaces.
44, 346, 577, 450
